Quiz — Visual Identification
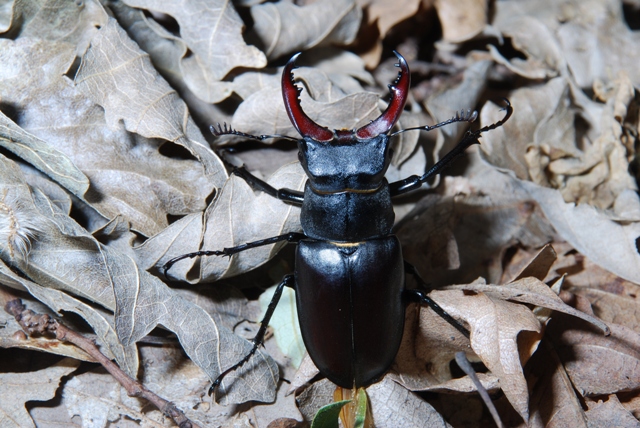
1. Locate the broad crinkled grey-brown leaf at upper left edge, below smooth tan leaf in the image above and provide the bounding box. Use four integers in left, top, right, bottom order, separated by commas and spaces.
0, 34, 225, 235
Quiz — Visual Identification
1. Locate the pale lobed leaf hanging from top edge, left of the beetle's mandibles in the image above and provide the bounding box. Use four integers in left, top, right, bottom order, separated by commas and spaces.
124, 0, 267, 103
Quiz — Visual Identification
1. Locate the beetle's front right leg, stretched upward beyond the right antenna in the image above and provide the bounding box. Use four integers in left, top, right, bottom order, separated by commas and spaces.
389, 99, 513, 196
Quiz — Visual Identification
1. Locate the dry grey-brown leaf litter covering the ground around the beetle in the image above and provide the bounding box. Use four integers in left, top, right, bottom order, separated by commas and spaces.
0, 0, 640, 427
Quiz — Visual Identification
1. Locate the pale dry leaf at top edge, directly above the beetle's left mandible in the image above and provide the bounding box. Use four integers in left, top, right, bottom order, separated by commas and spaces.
251, 0, 362, 59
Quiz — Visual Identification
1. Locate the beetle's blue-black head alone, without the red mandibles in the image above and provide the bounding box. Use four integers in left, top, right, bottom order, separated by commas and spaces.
298, 131, 391, 193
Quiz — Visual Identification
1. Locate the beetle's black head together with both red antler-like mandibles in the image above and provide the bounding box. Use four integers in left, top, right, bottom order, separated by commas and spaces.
282, 52, 411, 191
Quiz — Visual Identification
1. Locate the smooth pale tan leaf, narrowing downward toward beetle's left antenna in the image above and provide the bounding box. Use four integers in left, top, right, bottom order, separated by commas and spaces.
75, 18, 225, 181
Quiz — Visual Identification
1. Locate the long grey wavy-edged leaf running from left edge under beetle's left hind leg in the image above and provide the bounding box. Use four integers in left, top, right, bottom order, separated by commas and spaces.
0, 158, 278, 403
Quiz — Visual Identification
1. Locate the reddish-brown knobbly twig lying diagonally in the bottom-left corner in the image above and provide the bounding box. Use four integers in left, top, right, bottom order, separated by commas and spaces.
4, 299, 199, 428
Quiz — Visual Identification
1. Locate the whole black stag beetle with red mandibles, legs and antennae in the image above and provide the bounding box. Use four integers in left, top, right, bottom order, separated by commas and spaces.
164, 52, 513, 394
